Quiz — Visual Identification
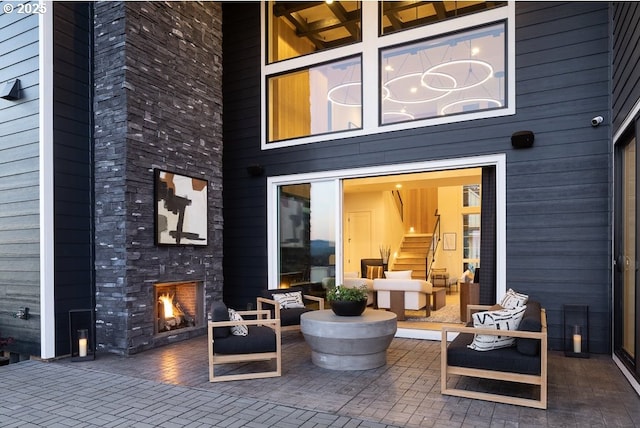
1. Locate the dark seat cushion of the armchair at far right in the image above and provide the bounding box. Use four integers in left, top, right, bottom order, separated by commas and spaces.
447, 333, 540, 375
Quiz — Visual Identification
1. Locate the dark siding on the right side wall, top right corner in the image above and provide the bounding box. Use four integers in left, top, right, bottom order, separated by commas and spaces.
612, 2, 640, 134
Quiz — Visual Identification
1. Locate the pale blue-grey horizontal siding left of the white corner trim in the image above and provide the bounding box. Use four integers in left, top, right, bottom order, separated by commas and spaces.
0, 8, 40, 355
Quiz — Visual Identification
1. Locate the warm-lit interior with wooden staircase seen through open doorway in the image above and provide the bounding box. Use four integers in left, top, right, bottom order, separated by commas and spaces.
342, 168, 482, 330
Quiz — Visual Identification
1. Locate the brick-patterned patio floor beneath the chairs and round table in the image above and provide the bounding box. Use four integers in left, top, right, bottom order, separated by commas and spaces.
0, 332, 640, 427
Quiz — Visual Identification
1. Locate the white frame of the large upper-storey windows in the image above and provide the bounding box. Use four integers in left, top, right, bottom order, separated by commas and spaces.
260, 0, 516, 150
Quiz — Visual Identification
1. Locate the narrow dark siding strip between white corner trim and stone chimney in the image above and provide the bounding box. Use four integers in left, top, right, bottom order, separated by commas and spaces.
52, 2, 94, 356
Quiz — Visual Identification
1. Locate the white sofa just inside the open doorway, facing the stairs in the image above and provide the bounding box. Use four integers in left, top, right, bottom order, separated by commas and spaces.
373, 272, 433, 320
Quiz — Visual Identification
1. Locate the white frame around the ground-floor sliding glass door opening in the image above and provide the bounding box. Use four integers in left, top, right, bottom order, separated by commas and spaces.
267, 153, 507, 340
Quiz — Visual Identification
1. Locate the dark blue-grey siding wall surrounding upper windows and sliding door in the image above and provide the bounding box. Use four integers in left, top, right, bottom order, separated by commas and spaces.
223, 2, 611, 352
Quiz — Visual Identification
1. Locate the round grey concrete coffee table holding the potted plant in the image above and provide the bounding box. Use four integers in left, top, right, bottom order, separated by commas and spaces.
300, 309, 397, 370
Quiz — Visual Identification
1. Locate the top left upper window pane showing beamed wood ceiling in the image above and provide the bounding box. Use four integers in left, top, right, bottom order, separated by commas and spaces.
267, 1, 362, 64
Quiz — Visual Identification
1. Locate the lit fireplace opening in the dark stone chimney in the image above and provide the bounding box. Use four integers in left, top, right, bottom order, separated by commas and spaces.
155, 281, 203, 334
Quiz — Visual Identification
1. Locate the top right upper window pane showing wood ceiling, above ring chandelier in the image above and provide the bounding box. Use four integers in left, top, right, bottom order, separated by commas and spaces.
380, 0, 507, 35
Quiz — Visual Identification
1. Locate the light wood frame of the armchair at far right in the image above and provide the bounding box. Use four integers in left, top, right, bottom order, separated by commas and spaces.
440, 305, 547, 409
